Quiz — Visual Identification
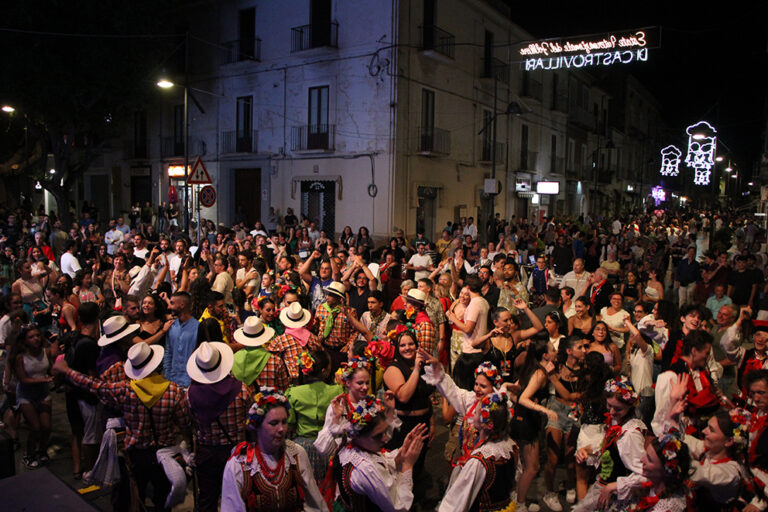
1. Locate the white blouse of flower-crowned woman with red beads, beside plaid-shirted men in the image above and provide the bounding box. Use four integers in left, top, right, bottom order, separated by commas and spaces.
221, 440, 328, 512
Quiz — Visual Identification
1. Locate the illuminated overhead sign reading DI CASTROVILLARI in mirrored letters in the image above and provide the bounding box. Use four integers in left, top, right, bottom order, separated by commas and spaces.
516, 27, 661, 71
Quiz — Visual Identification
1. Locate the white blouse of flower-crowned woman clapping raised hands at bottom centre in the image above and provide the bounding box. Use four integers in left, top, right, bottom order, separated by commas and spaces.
338, 446, 413, 512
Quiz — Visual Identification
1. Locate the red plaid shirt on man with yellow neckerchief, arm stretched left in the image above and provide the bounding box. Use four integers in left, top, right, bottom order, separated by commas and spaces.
67, 365, 190, 449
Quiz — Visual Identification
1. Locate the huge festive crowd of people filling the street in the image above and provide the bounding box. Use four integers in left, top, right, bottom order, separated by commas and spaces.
0, 204, 768, 512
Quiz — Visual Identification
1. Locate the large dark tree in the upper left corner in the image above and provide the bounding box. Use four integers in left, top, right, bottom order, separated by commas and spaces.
0, 0, 183, 225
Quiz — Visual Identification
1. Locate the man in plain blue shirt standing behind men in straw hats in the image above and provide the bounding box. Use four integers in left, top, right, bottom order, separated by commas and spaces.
163, 292, 199, 388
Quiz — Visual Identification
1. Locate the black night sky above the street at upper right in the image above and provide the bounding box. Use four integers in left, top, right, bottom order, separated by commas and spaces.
508, 0, 768, 176
